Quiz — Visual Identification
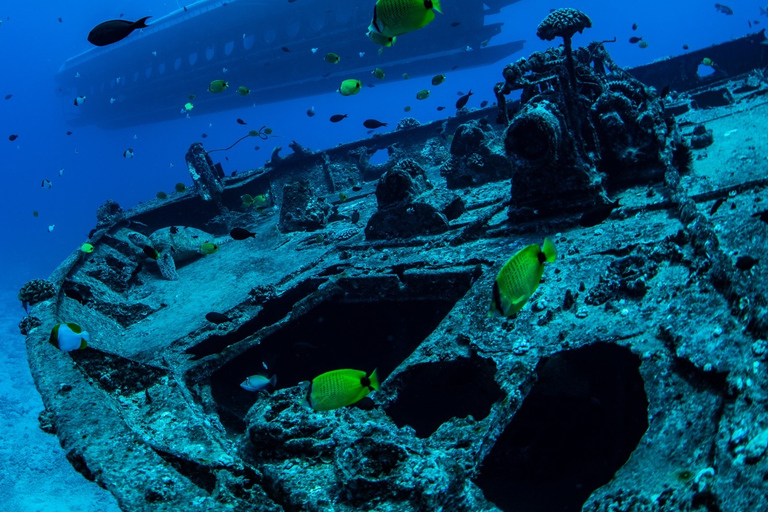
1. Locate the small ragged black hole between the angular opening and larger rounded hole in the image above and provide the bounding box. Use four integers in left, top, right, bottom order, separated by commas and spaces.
387, 356, 503, 438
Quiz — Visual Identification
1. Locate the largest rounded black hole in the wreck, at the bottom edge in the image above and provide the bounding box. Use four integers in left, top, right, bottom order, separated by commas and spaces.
476, 343, 648, 512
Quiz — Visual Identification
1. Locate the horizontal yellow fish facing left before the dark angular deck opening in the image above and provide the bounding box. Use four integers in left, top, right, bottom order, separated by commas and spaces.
306, 369, 379, 411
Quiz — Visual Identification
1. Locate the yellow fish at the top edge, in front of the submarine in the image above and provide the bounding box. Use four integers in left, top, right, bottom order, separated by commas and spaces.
368, 0, 442, 44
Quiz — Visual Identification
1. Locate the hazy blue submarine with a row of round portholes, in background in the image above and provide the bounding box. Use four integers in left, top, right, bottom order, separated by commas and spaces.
56, 0, 525, 129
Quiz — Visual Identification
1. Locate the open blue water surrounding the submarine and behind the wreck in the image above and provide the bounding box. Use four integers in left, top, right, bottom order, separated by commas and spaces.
0, 0, 768, 510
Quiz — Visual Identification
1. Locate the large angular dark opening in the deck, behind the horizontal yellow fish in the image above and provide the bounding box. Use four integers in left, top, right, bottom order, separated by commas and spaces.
210, 271, 473, 433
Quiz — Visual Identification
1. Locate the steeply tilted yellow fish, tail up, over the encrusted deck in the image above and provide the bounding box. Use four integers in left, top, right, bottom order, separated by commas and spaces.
488, 238, 557, 316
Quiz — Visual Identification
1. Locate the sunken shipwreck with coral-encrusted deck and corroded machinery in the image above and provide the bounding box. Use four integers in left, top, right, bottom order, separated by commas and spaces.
24, 21, 768, 512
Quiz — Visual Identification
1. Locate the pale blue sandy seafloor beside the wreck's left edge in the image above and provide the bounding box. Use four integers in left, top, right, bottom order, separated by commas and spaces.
0, 288, 120, 512
